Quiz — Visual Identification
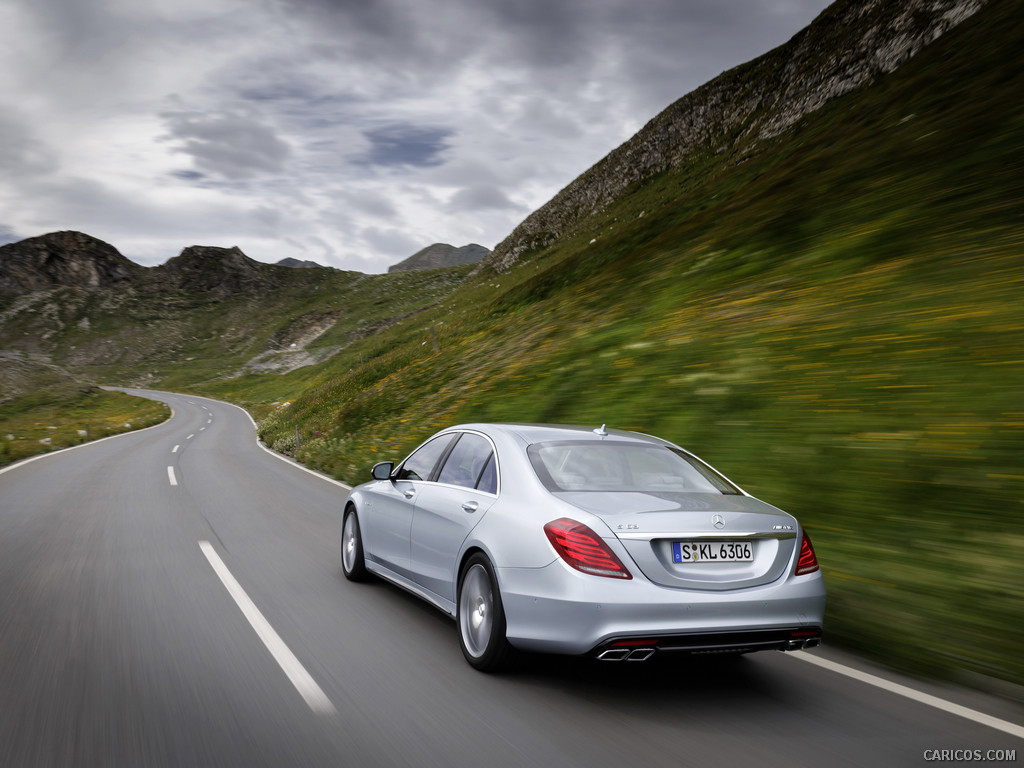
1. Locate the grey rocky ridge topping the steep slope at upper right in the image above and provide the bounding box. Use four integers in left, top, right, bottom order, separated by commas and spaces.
483, 0, 987, 271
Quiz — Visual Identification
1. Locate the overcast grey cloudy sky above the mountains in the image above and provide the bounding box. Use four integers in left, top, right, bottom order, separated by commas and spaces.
0, 0, 827, 272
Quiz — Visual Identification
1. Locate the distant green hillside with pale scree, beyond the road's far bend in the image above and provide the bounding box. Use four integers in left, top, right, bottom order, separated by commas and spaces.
0, 262, 469, 387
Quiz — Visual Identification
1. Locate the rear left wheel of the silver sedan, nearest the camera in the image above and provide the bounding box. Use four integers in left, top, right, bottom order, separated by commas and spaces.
456, 552, 512, 672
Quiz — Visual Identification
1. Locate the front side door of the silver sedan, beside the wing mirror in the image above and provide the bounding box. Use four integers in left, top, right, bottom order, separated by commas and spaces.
361, 433, 456, 578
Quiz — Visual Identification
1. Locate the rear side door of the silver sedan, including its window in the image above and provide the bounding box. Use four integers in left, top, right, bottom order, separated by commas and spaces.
410, 432, 498, 604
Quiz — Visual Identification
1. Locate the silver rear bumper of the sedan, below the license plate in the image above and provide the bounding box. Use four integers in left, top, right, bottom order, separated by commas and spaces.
498, 560, 825, 658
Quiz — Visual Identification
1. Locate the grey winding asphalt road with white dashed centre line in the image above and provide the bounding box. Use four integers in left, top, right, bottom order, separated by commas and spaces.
0, 393, 1024, 768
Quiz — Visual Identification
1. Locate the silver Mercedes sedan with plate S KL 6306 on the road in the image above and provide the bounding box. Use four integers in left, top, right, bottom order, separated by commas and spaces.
341, 424, 825, 671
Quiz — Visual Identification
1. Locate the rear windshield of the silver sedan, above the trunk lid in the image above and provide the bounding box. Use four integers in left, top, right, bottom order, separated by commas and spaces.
527, 440, 740, 495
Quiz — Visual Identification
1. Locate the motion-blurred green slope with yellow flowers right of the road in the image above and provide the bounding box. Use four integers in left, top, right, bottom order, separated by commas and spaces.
203, 2, 1024, 683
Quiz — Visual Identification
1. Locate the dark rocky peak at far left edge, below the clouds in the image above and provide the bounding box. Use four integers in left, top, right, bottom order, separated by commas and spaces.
0, 231, 145, 295
